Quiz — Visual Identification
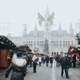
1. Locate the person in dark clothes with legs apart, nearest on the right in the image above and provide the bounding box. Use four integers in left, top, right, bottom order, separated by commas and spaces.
60, 55, 70, 78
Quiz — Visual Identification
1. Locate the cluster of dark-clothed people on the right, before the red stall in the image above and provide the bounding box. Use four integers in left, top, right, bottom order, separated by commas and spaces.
55, 53, 77, 79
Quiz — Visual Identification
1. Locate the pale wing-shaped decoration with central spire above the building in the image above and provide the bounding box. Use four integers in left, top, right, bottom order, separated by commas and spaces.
38, 7, 54, 32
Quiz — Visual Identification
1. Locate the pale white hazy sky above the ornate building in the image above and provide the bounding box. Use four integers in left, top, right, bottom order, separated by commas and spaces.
0, 0, 80, 36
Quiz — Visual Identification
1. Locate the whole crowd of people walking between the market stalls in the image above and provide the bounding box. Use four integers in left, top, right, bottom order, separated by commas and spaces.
5, 52, 76, 80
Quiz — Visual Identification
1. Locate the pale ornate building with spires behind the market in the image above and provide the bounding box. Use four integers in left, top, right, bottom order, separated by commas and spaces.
8, 9, 77, 53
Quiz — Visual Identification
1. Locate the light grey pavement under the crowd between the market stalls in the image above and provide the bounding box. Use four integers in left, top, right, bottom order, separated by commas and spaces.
0, 61, 80, 80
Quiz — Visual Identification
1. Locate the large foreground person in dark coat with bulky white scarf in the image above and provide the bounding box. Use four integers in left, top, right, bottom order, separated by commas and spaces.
5, 53, 27, 80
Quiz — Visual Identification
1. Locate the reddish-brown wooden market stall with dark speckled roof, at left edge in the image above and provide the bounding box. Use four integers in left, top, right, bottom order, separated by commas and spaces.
0, 36, 16, 69
